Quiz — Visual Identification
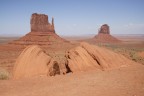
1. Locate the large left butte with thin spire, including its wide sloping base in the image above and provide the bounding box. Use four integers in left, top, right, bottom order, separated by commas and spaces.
9, 13, 69, 45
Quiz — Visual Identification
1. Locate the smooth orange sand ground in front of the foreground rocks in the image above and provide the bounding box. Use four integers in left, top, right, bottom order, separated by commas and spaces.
0, 64, 144, 96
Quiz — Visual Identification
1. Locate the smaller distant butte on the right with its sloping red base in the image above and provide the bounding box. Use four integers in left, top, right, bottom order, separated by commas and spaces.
94, 24, 121, 43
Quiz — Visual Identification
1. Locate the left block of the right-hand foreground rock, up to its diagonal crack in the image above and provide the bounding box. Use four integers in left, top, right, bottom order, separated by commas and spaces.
66, 46, 100, 72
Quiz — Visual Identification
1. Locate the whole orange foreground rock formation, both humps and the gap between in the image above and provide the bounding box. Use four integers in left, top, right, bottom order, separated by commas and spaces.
13, 42, 137, 79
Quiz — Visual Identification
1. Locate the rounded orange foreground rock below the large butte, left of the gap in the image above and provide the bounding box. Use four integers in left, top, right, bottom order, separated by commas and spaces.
13, 45, 60, 79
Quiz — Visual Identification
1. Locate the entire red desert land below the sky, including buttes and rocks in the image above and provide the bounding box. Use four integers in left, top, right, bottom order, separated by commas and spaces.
0, 13, 144, 96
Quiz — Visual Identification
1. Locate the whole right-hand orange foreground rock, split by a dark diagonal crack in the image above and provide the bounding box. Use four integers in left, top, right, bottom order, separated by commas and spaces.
66, 43, 133, 72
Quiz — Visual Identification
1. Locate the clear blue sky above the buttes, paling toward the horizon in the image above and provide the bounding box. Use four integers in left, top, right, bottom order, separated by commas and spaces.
0, 0, 144, 36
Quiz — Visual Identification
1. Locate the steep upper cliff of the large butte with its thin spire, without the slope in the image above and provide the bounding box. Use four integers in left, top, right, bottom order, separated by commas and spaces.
30, 13, 55, 33
